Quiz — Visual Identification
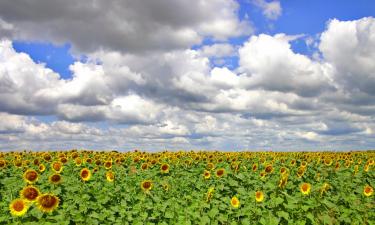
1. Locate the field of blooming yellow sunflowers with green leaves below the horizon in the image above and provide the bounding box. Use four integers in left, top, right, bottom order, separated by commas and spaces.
0, 150, 375, 225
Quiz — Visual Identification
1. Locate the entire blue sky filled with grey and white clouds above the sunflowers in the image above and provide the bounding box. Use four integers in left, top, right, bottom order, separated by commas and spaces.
0, 0, 375, 151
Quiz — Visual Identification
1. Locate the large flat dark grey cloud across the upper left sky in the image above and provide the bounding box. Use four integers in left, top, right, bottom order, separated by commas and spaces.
0, 0, 252, 52
